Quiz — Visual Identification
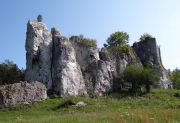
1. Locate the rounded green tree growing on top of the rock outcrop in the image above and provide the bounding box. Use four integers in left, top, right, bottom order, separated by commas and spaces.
107, 32, 129, 46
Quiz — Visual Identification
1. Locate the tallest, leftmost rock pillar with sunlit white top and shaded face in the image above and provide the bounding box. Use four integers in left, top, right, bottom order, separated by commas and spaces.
25, 21, 52, 89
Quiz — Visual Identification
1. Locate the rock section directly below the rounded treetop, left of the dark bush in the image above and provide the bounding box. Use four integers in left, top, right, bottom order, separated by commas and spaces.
100, 47, 142, 90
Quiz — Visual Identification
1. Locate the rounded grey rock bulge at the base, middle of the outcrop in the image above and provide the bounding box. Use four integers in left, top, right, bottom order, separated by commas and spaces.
84, 60, 113, 96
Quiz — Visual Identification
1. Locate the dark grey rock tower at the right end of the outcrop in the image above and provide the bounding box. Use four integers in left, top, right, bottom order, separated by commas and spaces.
133, 38, 172, 88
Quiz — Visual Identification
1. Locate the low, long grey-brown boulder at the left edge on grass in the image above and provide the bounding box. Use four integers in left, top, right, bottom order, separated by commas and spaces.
0, 81, 47, 106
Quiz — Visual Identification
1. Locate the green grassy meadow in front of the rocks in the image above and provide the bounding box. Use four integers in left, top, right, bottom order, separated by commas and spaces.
0, 90, 180, 123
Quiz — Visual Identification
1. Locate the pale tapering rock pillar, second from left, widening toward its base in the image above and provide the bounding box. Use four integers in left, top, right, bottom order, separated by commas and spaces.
53, 36, 87, 96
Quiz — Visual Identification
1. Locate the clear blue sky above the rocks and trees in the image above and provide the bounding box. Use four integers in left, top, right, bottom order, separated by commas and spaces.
0, 0, 180, 69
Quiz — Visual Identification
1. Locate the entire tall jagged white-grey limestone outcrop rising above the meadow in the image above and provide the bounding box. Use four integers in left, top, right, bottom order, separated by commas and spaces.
26, 16, 171, 96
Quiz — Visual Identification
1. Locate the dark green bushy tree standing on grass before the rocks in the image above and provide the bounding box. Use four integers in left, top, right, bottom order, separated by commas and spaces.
123, 65, 159, 93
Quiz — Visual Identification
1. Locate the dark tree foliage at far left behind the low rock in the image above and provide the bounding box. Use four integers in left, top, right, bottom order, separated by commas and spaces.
0, 60, 24, 85
